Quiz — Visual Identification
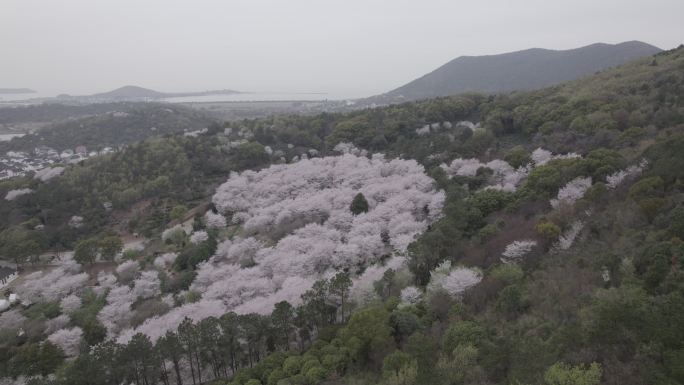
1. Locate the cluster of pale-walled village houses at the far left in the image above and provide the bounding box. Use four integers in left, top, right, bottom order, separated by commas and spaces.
0, 146, 114, 180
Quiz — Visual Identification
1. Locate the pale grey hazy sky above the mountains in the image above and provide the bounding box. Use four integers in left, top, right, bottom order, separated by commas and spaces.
0, 0, 684, 97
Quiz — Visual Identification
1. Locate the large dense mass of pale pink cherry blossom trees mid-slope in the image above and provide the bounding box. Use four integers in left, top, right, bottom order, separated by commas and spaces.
118, 152, 444, 341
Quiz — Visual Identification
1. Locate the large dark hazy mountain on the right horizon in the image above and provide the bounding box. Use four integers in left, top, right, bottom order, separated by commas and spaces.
367, 41, 662, 102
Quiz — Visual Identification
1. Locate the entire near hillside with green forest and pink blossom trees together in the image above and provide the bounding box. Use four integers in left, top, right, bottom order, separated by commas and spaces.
0, 46, 684, 385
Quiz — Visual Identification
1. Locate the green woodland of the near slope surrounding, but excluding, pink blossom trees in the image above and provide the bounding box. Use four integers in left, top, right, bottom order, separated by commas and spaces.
0, 46, 684, 385
